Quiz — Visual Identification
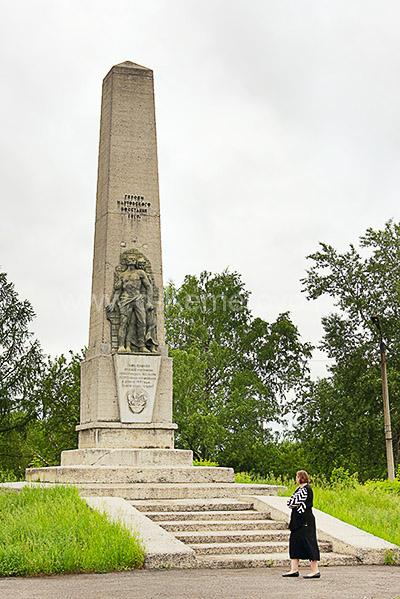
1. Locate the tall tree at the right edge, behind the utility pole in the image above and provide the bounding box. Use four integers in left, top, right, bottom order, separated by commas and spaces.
296, 221, 400, 478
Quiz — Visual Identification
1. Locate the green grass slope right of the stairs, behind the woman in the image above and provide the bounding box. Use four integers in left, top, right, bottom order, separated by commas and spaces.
235, 472, 400, 546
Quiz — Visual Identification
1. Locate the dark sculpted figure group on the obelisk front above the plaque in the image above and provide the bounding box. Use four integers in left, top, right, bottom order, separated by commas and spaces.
106, 254, 157, 353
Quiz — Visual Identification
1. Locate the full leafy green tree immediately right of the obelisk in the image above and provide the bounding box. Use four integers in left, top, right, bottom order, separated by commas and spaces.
165, 271, 311, 472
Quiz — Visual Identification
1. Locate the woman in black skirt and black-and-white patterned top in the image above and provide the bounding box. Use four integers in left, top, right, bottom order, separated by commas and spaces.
282, 470, 321, 578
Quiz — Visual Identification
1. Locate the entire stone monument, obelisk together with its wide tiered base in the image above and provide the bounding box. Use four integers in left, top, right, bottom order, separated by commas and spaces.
26, 61, 234, 498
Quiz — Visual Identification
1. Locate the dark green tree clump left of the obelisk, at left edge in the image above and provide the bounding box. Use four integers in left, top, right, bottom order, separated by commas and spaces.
0, 273, 82, 477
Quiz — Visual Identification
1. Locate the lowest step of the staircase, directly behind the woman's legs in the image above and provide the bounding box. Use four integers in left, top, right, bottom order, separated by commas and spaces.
197, 552, 359, 573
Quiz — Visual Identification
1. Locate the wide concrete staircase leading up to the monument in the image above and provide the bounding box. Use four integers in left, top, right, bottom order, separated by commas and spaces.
131, 499, 358, 568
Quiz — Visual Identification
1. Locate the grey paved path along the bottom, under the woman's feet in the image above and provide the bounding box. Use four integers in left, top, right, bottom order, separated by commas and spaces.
0, 566, 400, 599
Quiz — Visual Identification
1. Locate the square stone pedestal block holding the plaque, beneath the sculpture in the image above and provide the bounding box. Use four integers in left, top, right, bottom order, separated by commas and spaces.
77, 354, 177, 449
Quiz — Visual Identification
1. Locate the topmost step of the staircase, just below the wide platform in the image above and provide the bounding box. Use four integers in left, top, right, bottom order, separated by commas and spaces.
131, 498, 254, 517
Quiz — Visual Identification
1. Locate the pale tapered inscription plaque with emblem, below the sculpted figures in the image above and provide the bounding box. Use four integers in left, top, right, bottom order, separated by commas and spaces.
114, 354, 161, 422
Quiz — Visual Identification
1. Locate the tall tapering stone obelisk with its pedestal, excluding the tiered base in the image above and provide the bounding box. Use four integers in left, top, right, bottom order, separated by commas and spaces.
78, 62, 176, 448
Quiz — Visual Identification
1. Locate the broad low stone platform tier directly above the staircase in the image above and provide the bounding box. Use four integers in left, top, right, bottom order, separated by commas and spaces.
72, 482, 282, 500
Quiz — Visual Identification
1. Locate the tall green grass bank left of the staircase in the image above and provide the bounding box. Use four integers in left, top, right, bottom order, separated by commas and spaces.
0, 487, 144, 576
